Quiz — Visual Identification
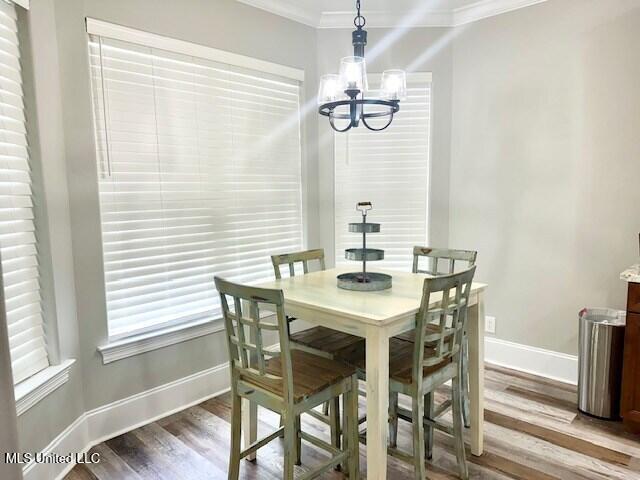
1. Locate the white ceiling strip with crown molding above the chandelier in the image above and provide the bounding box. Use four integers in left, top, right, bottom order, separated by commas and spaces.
238, 0, 546, 28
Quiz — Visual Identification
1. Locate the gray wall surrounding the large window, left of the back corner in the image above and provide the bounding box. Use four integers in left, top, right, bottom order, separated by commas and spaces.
19, 0, 319, 458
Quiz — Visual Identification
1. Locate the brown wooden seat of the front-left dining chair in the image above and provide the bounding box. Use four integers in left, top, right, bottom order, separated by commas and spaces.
249, 350, 356, 403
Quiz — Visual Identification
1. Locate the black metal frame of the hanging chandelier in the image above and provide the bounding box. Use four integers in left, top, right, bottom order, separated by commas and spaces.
318, 0, 400, 133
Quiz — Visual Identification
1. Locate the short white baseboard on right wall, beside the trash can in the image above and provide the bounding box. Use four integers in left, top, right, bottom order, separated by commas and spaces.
484, 337, 578, 385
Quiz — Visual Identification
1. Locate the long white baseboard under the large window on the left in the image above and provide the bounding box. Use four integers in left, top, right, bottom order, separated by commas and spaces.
23, 363, 229, 480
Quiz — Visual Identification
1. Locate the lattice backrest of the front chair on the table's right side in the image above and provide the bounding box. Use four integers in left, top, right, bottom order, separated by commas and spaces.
413, 266, 476, 383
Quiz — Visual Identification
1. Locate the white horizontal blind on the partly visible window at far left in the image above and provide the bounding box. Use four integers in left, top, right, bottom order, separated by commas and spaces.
0, 2, 49, 383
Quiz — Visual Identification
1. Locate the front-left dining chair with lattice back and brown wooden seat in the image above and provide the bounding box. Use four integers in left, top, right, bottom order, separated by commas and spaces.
215, 277, 359, 480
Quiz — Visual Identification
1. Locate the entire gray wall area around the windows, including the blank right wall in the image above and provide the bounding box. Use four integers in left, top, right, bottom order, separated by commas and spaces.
18, 0, 640, 462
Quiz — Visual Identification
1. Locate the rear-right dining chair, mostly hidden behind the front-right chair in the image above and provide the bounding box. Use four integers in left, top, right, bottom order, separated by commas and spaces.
396, 246, 478, 428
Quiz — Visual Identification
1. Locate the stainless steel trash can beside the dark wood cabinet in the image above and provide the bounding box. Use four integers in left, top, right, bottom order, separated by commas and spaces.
578, 308, 626, 419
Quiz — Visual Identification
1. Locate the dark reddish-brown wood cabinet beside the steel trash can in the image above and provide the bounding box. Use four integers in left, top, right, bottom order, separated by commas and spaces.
620, 283, 640, 433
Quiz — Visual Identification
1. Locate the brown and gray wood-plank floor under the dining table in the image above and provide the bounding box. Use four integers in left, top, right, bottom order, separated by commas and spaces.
66, 365, 640, 480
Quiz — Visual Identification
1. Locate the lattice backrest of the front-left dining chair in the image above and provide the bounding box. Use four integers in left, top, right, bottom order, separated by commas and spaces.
215, 277, 293, 402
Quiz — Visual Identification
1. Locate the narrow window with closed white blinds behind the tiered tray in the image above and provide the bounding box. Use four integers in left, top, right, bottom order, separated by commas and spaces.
335, 74, 431, 272
